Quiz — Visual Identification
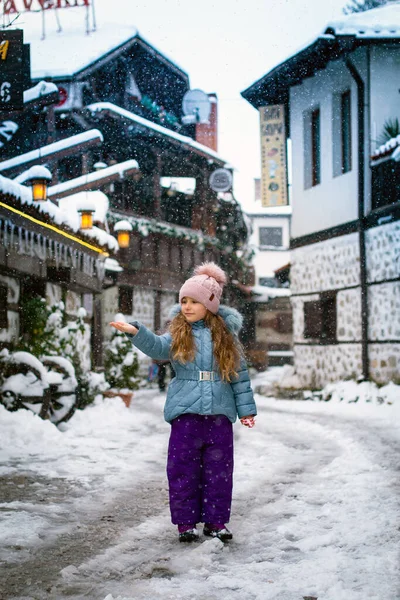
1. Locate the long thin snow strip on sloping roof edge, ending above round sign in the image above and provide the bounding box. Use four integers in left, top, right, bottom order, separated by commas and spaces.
86, 102, 226, 165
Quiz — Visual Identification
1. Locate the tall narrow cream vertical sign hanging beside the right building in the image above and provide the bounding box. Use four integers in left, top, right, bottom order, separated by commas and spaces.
259, 104, 288, 206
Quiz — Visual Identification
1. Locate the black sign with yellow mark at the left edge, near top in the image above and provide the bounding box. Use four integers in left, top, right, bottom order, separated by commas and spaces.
0, 29, 24, 112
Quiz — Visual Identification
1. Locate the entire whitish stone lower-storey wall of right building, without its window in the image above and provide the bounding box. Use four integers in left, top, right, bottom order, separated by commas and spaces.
291, 222, 400, 386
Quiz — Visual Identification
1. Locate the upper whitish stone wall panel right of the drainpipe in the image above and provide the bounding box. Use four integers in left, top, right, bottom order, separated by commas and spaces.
365, 221, 400, 282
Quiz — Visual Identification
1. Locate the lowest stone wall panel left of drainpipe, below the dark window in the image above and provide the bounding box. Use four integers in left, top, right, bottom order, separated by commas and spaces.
294, 344, 362, 388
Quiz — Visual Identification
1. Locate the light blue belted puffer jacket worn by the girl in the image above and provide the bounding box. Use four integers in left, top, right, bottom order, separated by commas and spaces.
127, 305, 257, 423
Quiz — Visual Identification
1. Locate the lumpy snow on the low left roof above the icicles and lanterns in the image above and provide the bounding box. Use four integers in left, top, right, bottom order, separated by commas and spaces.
0, 175, 119, 252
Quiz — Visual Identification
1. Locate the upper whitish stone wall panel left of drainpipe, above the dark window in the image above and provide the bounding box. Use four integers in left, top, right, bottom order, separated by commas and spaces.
290, 233, 360, 294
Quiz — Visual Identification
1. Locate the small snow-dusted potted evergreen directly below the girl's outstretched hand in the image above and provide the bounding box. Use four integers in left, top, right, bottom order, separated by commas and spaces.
104, 314, 139, 390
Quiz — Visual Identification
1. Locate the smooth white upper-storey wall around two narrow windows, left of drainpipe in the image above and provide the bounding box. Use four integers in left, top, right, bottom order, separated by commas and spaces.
290, 55, 362, 238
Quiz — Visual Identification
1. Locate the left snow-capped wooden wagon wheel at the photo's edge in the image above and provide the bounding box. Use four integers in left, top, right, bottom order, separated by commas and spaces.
0, 352, 50, 419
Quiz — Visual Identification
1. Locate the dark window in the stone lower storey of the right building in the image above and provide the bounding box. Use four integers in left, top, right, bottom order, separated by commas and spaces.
304, 292, 336, 344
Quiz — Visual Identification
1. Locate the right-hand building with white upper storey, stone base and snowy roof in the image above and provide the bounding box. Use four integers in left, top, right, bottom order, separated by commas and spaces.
243, 2, 400, 387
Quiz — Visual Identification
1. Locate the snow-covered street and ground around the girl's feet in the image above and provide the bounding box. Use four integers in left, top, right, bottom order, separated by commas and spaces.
0, 370, 400, 600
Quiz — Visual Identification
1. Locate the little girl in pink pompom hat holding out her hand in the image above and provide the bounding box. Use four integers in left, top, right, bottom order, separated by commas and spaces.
110, 263, 257, 542
